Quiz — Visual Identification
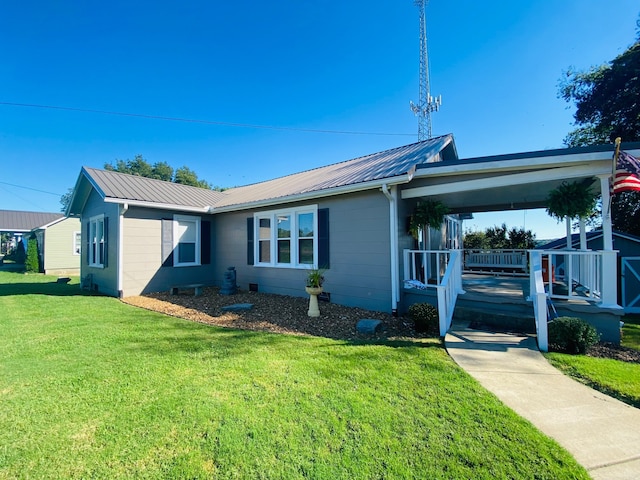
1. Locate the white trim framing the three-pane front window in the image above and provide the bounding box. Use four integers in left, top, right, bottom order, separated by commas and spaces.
253, 205, 318, 269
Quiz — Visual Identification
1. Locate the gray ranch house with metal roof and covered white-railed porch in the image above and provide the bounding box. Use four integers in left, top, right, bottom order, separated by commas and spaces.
67, 135, 640, 349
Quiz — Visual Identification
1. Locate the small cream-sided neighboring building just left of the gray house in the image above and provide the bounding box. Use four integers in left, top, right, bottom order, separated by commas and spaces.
32, 217, 82, 275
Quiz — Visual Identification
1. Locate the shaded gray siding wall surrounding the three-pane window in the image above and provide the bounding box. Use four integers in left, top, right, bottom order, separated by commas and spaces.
214, 191, 391, 311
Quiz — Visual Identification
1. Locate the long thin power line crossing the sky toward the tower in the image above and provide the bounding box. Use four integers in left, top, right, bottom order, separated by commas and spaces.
0, 101, 414, 137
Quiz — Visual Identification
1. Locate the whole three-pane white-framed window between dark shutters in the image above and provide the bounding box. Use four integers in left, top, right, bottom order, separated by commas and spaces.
254, 206, 318, 268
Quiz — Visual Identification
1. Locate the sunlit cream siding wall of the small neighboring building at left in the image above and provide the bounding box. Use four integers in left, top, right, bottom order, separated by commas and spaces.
38, 218, 81, 275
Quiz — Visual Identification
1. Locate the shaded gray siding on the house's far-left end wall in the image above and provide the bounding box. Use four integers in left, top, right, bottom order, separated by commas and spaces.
80, 190, 119, 297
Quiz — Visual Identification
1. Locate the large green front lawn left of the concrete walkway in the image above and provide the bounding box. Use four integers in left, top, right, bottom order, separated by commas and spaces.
0, 272, 588, 479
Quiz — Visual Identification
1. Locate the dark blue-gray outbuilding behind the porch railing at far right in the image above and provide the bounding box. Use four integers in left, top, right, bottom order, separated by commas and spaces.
537, 230, 640, 313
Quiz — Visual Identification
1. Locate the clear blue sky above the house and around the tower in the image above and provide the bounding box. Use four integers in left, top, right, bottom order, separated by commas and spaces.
0, 0, 640, 238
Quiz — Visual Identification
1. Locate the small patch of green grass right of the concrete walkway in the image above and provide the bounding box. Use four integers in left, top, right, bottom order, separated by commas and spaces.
545, 315, 640, 408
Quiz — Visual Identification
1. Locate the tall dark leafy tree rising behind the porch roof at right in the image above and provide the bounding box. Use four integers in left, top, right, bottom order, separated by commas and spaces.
560, 26, 640, 235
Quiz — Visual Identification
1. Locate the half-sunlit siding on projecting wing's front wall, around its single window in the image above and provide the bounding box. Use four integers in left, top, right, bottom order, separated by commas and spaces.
122, 207, 215, 297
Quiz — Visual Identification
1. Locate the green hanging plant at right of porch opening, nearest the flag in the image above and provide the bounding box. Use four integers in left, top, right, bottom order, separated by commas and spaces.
546, 177, 598, 221
